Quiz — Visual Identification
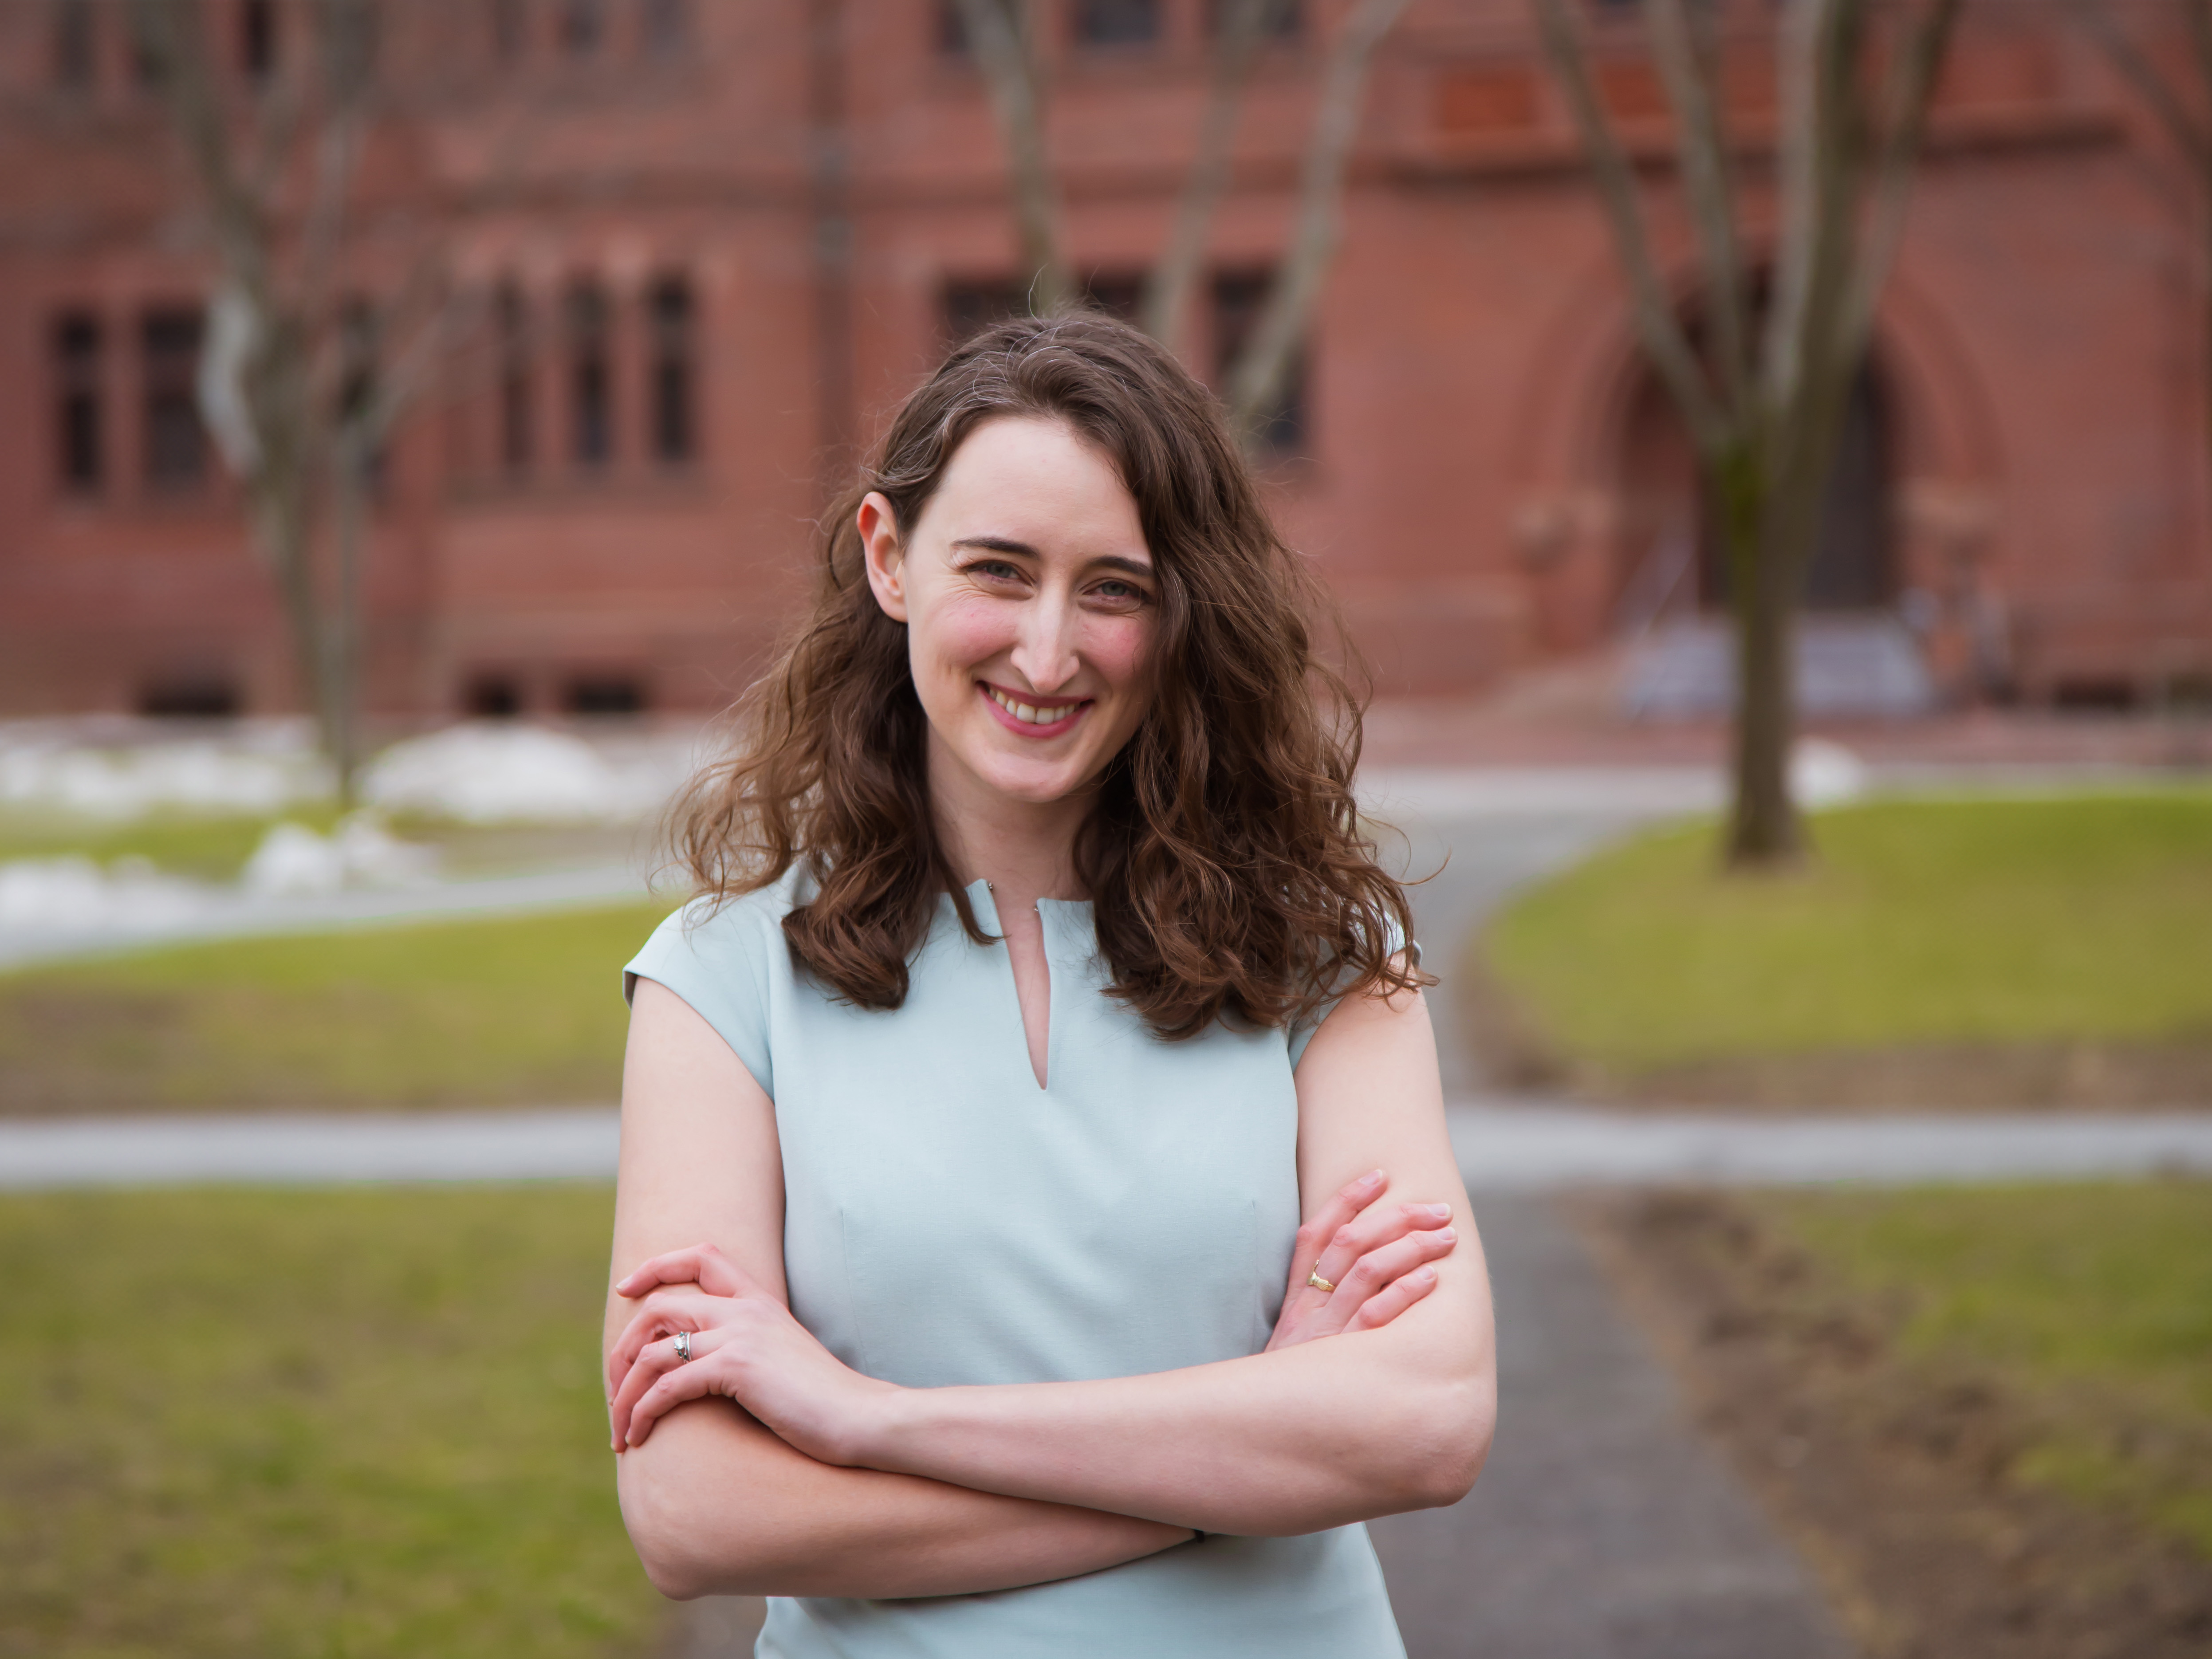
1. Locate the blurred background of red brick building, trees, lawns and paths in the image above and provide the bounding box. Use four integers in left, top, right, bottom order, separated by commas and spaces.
0, 0, 2212, 1659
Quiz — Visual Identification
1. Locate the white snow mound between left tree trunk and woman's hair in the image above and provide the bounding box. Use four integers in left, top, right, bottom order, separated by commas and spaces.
361, 723, 681, 823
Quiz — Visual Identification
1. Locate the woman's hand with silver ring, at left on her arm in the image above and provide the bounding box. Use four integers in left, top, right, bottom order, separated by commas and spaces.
606, 1245, 896, 1464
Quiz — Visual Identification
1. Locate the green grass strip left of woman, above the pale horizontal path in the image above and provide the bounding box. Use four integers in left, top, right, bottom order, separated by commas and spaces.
0, 903, 670, 1113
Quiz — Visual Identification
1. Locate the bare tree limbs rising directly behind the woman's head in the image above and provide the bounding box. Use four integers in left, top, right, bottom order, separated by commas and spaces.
960, 0, 1407, 442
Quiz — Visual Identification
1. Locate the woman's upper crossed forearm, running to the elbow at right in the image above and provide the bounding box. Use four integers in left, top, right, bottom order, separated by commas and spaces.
850, 1318, 1496, 1535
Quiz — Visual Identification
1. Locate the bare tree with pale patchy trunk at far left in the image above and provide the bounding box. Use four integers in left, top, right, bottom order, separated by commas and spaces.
128, 0, 475, 807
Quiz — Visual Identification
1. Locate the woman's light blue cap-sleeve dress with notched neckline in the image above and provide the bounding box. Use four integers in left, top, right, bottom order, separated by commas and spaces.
624, 872, 1405, 1659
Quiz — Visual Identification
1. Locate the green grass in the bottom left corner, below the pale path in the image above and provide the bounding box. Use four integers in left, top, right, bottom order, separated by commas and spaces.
0, 1186, 661, 1659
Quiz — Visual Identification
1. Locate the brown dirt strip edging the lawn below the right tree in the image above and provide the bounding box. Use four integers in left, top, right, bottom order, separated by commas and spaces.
1453, 962, 2212, 1113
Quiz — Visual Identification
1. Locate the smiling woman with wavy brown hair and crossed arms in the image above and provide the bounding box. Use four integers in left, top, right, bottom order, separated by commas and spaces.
606, 316, 1496, 1659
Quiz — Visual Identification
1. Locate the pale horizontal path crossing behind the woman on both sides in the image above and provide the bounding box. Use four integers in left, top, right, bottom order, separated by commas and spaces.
0, 1106, 2212, 1215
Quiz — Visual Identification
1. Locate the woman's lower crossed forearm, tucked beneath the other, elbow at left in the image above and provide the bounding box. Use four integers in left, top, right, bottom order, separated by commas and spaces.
617, 1400, 1190, 1599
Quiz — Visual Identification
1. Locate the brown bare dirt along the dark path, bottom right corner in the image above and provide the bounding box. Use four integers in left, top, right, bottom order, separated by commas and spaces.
1573, 1192, 2212, 1659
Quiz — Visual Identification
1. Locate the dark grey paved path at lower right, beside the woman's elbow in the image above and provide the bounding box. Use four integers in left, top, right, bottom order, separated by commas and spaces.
1371, 1197, 1845, 1659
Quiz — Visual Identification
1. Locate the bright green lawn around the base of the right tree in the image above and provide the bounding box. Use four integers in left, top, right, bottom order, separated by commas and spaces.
1482, 790, 2212, 1071
